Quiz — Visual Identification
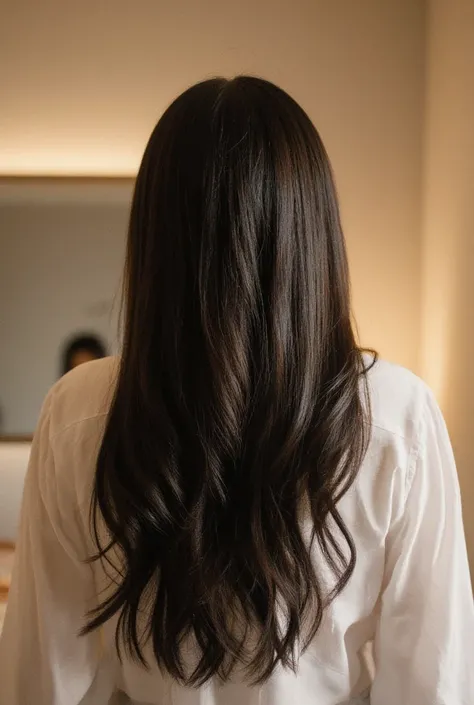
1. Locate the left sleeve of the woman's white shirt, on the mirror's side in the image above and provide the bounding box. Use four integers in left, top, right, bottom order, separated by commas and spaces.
0, 388, 115, 705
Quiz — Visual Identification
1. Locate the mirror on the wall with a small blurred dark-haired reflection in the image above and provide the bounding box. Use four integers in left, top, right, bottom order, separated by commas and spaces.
0, 178, 133, 438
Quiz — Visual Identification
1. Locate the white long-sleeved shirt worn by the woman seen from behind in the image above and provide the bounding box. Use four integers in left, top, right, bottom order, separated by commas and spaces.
0, 360, 474, 705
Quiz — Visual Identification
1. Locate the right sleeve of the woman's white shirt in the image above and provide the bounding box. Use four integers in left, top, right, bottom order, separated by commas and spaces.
371, 395, 474, 705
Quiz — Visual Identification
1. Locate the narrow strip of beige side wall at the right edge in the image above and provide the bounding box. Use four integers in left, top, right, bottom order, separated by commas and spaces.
422, 0, 474, 567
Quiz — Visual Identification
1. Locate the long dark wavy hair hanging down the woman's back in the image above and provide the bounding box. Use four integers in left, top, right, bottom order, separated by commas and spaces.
85, 77, 370, 685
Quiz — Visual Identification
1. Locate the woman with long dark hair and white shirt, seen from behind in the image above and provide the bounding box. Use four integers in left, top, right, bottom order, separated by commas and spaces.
0, 77, 474, 705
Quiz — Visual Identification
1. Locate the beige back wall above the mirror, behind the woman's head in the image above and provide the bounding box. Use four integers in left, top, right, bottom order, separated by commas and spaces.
0, 0, 425, 369
